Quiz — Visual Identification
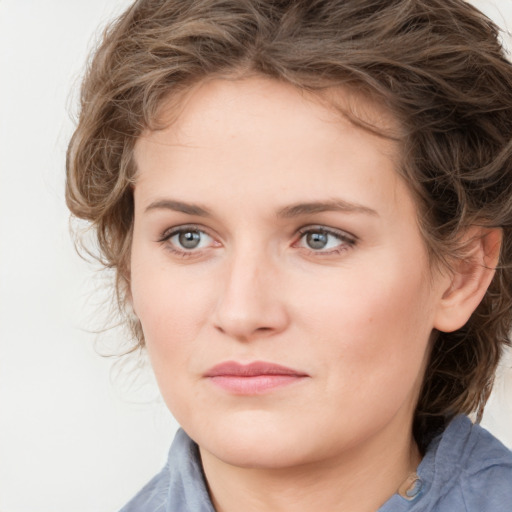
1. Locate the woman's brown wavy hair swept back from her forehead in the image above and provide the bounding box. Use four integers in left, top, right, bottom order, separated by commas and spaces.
66, 0, 512, 446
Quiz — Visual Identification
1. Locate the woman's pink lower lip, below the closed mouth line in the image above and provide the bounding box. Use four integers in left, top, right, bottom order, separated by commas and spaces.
208, 375, 305, 395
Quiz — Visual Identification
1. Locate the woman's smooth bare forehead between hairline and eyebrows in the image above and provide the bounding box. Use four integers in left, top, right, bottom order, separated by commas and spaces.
135, 78, 412, 218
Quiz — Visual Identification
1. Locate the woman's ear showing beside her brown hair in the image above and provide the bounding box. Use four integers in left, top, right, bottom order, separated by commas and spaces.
434, 226, 502, 332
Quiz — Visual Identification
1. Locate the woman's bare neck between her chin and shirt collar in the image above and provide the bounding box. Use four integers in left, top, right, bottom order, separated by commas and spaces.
201, 418, 421, 512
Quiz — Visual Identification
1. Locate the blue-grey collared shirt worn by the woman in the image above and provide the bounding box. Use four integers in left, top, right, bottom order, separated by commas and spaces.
120, 416, 512, 512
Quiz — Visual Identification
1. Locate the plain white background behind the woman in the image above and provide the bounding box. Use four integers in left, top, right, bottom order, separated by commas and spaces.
0, 0, 512, 512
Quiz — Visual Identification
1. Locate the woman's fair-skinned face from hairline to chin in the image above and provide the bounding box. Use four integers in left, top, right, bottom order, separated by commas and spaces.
131, 78, 446, 467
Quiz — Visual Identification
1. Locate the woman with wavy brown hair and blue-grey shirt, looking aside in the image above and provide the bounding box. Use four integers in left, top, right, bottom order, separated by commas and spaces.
67, 0, 512, 512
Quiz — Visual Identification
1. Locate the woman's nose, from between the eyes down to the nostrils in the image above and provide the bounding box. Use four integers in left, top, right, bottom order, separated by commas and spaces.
213, 246, 289, 341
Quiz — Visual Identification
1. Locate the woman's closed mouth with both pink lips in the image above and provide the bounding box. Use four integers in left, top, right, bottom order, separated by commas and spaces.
204, 361, 309, 395
